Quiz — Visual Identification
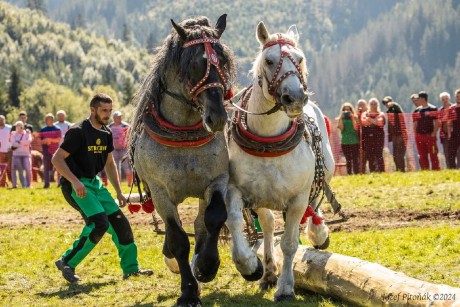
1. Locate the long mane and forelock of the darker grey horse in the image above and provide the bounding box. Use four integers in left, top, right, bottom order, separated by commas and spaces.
128, 16, 236, 148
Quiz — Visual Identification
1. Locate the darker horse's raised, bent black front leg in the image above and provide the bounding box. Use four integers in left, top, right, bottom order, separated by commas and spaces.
192, 190, 227, 282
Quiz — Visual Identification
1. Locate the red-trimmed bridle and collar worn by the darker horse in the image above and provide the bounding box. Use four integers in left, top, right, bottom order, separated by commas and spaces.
143, 30, 233, 147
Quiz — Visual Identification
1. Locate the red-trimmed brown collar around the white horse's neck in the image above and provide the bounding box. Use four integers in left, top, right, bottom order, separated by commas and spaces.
230, 91, 305, 157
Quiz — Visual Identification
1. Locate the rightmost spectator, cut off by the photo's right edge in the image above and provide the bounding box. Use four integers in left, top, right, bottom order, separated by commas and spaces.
447, 88, 460, 168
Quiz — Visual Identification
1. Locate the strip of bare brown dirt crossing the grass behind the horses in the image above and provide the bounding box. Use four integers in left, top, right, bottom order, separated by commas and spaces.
0, 205, 460, 232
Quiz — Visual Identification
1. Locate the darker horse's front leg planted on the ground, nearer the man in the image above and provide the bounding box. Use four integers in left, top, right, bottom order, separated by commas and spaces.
154, 199, 201, 306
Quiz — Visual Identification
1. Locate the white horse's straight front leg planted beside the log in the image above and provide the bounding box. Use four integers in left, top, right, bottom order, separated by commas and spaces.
275, 194, 308, 302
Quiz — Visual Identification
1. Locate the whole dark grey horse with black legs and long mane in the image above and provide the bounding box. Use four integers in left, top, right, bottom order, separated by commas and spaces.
130, 15, 236, 306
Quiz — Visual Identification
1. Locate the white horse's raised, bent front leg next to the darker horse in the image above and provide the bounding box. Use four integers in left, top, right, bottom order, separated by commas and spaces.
226, 185, 263, 281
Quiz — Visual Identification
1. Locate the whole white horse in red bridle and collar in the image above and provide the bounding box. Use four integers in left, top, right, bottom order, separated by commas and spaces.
226, 22, 334, 301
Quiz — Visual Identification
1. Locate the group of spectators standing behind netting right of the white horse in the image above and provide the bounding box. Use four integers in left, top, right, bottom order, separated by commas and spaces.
331, 88, 460, 174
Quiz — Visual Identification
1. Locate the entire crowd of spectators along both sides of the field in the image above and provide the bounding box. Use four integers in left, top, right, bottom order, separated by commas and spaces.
0, 88, 460, 188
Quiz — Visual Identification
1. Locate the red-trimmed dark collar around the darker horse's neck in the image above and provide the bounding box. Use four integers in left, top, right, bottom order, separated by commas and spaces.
143, 103, 216, 147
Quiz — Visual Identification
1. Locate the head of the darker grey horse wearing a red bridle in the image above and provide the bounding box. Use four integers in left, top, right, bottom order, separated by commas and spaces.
171, 14, 235, 132
